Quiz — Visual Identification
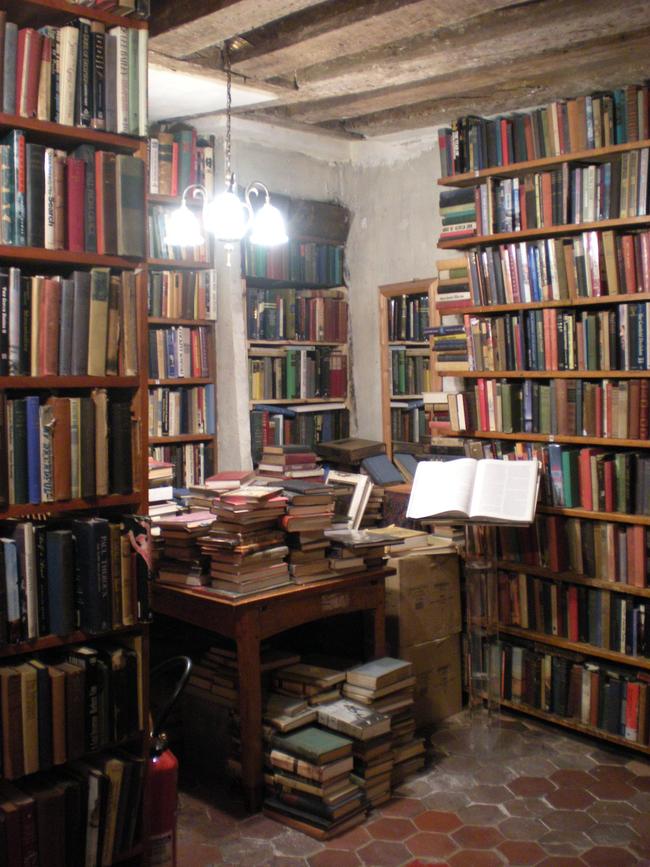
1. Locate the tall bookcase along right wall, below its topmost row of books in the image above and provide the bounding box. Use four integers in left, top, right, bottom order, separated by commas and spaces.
434, 105, 650, 754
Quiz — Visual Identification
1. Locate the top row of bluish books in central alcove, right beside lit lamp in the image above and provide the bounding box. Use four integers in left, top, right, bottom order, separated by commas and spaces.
242, 240, 343, 286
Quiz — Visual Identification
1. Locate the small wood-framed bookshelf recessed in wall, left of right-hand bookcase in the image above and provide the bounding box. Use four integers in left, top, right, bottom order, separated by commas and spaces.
379, 279, 437, 457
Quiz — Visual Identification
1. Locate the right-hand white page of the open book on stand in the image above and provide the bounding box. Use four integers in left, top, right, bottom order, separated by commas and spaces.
469, 460, 539, 523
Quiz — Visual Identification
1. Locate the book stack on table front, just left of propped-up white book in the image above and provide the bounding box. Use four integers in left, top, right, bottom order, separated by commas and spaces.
282, 480, 335, 584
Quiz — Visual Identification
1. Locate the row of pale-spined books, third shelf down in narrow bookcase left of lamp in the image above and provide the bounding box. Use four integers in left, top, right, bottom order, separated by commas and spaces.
147, 268, 217, 319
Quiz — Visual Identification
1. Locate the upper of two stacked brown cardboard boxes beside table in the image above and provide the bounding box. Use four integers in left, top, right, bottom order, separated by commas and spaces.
386, 553, 462, 648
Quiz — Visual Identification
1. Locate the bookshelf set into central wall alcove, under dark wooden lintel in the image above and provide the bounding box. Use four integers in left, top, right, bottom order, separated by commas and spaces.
242, 194, 351, 463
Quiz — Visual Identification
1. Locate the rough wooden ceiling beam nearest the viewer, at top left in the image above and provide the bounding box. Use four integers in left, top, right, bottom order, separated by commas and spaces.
149, 0, 322, 57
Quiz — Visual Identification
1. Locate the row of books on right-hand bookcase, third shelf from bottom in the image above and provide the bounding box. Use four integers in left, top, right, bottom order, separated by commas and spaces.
499, 515, 650, 587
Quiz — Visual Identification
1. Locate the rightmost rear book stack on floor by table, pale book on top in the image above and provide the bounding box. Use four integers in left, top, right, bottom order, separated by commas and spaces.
343, 657, 424, 787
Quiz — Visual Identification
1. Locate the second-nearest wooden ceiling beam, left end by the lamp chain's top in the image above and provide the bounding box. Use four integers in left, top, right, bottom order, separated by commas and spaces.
232, 0, 519, 78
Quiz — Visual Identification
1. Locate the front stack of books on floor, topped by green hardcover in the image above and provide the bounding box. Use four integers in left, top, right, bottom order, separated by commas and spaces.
264, 726, 367, 839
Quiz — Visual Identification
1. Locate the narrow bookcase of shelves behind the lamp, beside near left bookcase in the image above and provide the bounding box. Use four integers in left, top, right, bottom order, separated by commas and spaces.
147, 131, 217, 488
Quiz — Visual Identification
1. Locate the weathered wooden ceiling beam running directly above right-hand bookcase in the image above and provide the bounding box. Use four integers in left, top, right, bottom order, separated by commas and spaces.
331, 28, 650, 136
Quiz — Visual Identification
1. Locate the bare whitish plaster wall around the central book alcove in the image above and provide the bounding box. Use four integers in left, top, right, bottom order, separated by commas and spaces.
191, 118, 440, 469
